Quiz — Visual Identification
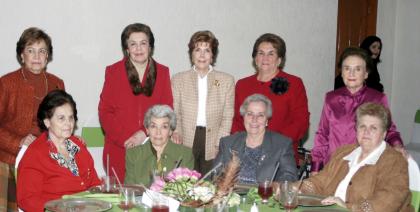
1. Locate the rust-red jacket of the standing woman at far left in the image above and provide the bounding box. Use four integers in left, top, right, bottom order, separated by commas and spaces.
0, 69, 64, 164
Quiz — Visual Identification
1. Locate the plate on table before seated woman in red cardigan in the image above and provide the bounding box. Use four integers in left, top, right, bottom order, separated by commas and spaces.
45, 199, 112, 212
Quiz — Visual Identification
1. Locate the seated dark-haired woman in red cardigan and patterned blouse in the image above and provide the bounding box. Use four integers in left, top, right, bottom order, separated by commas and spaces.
17, 90, 101, 211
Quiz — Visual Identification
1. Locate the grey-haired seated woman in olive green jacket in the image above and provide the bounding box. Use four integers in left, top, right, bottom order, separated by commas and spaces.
124, 105, 194, 186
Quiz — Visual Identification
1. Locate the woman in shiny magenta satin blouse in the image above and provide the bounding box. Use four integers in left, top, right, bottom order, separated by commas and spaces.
312, 47, 405, 173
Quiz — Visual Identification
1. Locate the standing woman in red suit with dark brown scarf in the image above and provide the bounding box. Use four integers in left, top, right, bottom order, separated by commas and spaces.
99, 23, 173, 180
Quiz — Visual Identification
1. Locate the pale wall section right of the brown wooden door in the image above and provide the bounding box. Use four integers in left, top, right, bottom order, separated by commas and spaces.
377, 0, 420, 144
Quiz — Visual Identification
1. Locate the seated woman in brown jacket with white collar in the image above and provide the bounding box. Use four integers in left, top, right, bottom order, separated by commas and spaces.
301, 103, 412, 211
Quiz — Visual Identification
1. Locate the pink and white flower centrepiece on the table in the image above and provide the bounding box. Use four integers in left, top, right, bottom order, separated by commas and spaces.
150, 152, 240, 208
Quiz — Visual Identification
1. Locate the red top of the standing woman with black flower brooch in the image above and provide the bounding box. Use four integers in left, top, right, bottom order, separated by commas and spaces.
232, 70, 309, 157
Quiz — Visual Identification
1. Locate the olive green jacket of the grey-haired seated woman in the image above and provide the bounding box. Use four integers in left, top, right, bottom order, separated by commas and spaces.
124, 140, 194, 186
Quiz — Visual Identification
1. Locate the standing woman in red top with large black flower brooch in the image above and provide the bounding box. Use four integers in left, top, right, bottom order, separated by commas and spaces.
232, 33, 309, 158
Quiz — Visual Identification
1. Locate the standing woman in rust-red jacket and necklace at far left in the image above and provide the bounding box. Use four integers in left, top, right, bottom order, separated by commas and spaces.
0, 27, 64, 211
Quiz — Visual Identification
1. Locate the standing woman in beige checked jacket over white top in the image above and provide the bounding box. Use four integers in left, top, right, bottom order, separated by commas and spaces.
172, 31, 235, 174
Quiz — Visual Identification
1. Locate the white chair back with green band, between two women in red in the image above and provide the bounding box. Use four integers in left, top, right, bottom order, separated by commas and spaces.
82, 127, 106, 176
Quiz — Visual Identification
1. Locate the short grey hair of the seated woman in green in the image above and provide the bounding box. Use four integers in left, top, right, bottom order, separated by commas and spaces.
143, 105, 176, 131
